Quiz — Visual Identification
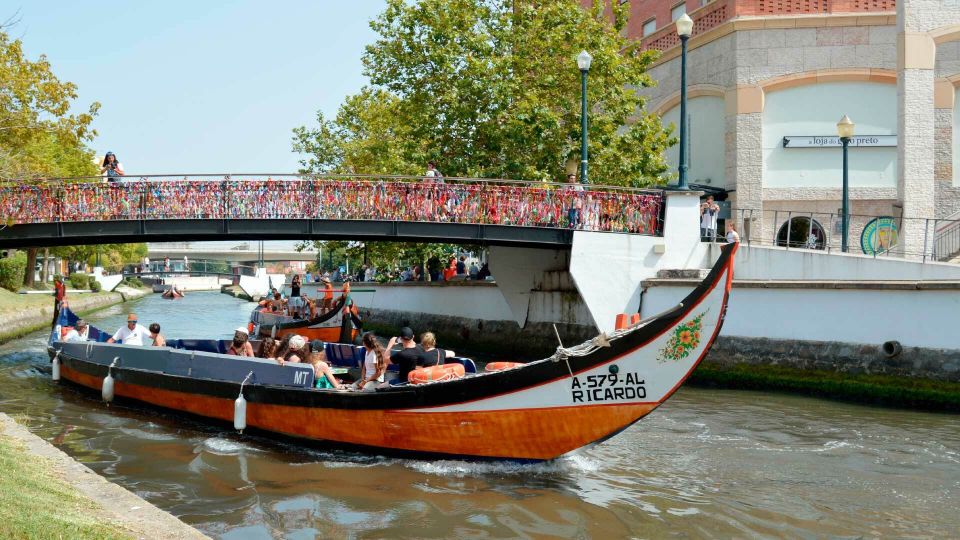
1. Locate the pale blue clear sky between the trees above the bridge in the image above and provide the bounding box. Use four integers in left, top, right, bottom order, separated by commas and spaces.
7, 0, 384, 175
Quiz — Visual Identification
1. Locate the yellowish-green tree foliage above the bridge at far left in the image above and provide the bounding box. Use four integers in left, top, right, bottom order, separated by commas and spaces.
0, 31, 100, 180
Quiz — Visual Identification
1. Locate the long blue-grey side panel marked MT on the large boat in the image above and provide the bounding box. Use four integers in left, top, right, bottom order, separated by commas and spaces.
55, 340, 314, 388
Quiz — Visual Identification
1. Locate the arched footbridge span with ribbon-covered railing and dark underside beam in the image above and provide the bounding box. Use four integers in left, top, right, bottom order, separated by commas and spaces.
0, 175, 663, 248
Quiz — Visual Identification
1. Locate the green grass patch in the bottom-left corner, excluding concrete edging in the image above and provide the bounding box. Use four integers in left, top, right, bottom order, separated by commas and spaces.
0, 433, 131, 539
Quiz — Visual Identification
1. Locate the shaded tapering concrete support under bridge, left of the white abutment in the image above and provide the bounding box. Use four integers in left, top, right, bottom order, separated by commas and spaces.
490, 246, 570, 328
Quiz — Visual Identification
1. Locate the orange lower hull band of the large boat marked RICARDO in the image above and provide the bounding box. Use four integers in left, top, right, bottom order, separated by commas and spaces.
61, 366, 660, 460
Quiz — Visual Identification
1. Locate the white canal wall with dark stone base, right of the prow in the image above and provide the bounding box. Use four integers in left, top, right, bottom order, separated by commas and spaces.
641, 279, 960, 382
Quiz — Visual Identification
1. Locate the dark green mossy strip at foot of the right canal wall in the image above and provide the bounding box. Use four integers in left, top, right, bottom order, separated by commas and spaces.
689, 362, 960, 412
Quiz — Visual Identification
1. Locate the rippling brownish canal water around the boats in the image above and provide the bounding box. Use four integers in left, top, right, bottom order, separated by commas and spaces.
0, 293, 960, 539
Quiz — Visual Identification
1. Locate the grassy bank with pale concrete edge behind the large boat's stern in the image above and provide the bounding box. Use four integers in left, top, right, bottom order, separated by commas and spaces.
0, 287, 150, 343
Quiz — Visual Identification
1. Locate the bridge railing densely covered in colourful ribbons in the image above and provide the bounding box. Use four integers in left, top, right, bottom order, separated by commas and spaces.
0, 175, 663, 235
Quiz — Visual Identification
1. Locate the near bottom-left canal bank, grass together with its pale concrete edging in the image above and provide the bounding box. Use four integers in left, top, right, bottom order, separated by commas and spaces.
0, 413, 207, 539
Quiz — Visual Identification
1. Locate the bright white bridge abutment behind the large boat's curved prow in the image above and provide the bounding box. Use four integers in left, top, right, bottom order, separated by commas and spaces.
568, 191, 710, 332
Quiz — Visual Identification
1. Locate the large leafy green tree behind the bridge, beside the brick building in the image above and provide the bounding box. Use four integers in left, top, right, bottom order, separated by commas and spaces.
293, 0, 674, 186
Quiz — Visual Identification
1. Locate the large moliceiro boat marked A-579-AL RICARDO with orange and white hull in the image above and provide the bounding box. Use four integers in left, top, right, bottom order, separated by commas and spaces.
49, 244, 737, 461
